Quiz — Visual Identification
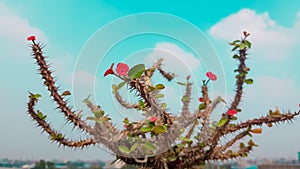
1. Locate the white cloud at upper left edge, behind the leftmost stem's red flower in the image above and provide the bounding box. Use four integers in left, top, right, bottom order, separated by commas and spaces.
0, 4, 46, 42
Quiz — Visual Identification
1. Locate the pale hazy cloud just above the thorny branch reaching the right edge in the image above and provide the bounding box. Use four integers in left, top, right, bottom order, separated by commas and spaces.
243, 76, 300, 117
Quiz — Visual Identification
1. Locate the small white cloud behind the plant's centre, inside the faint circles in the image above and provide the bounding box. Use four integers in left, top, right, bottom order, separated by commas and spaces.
145, 43, 200, 75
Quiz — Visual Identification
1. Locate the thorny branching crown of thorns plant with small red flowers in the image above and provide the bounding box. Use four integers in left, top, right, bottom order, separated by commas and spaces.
27, 31, 300, 169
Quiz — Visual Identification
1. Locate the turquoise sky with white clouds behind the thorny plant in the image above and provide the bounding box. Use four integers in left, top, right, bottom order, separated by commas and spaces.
0, 0, 300, 159
